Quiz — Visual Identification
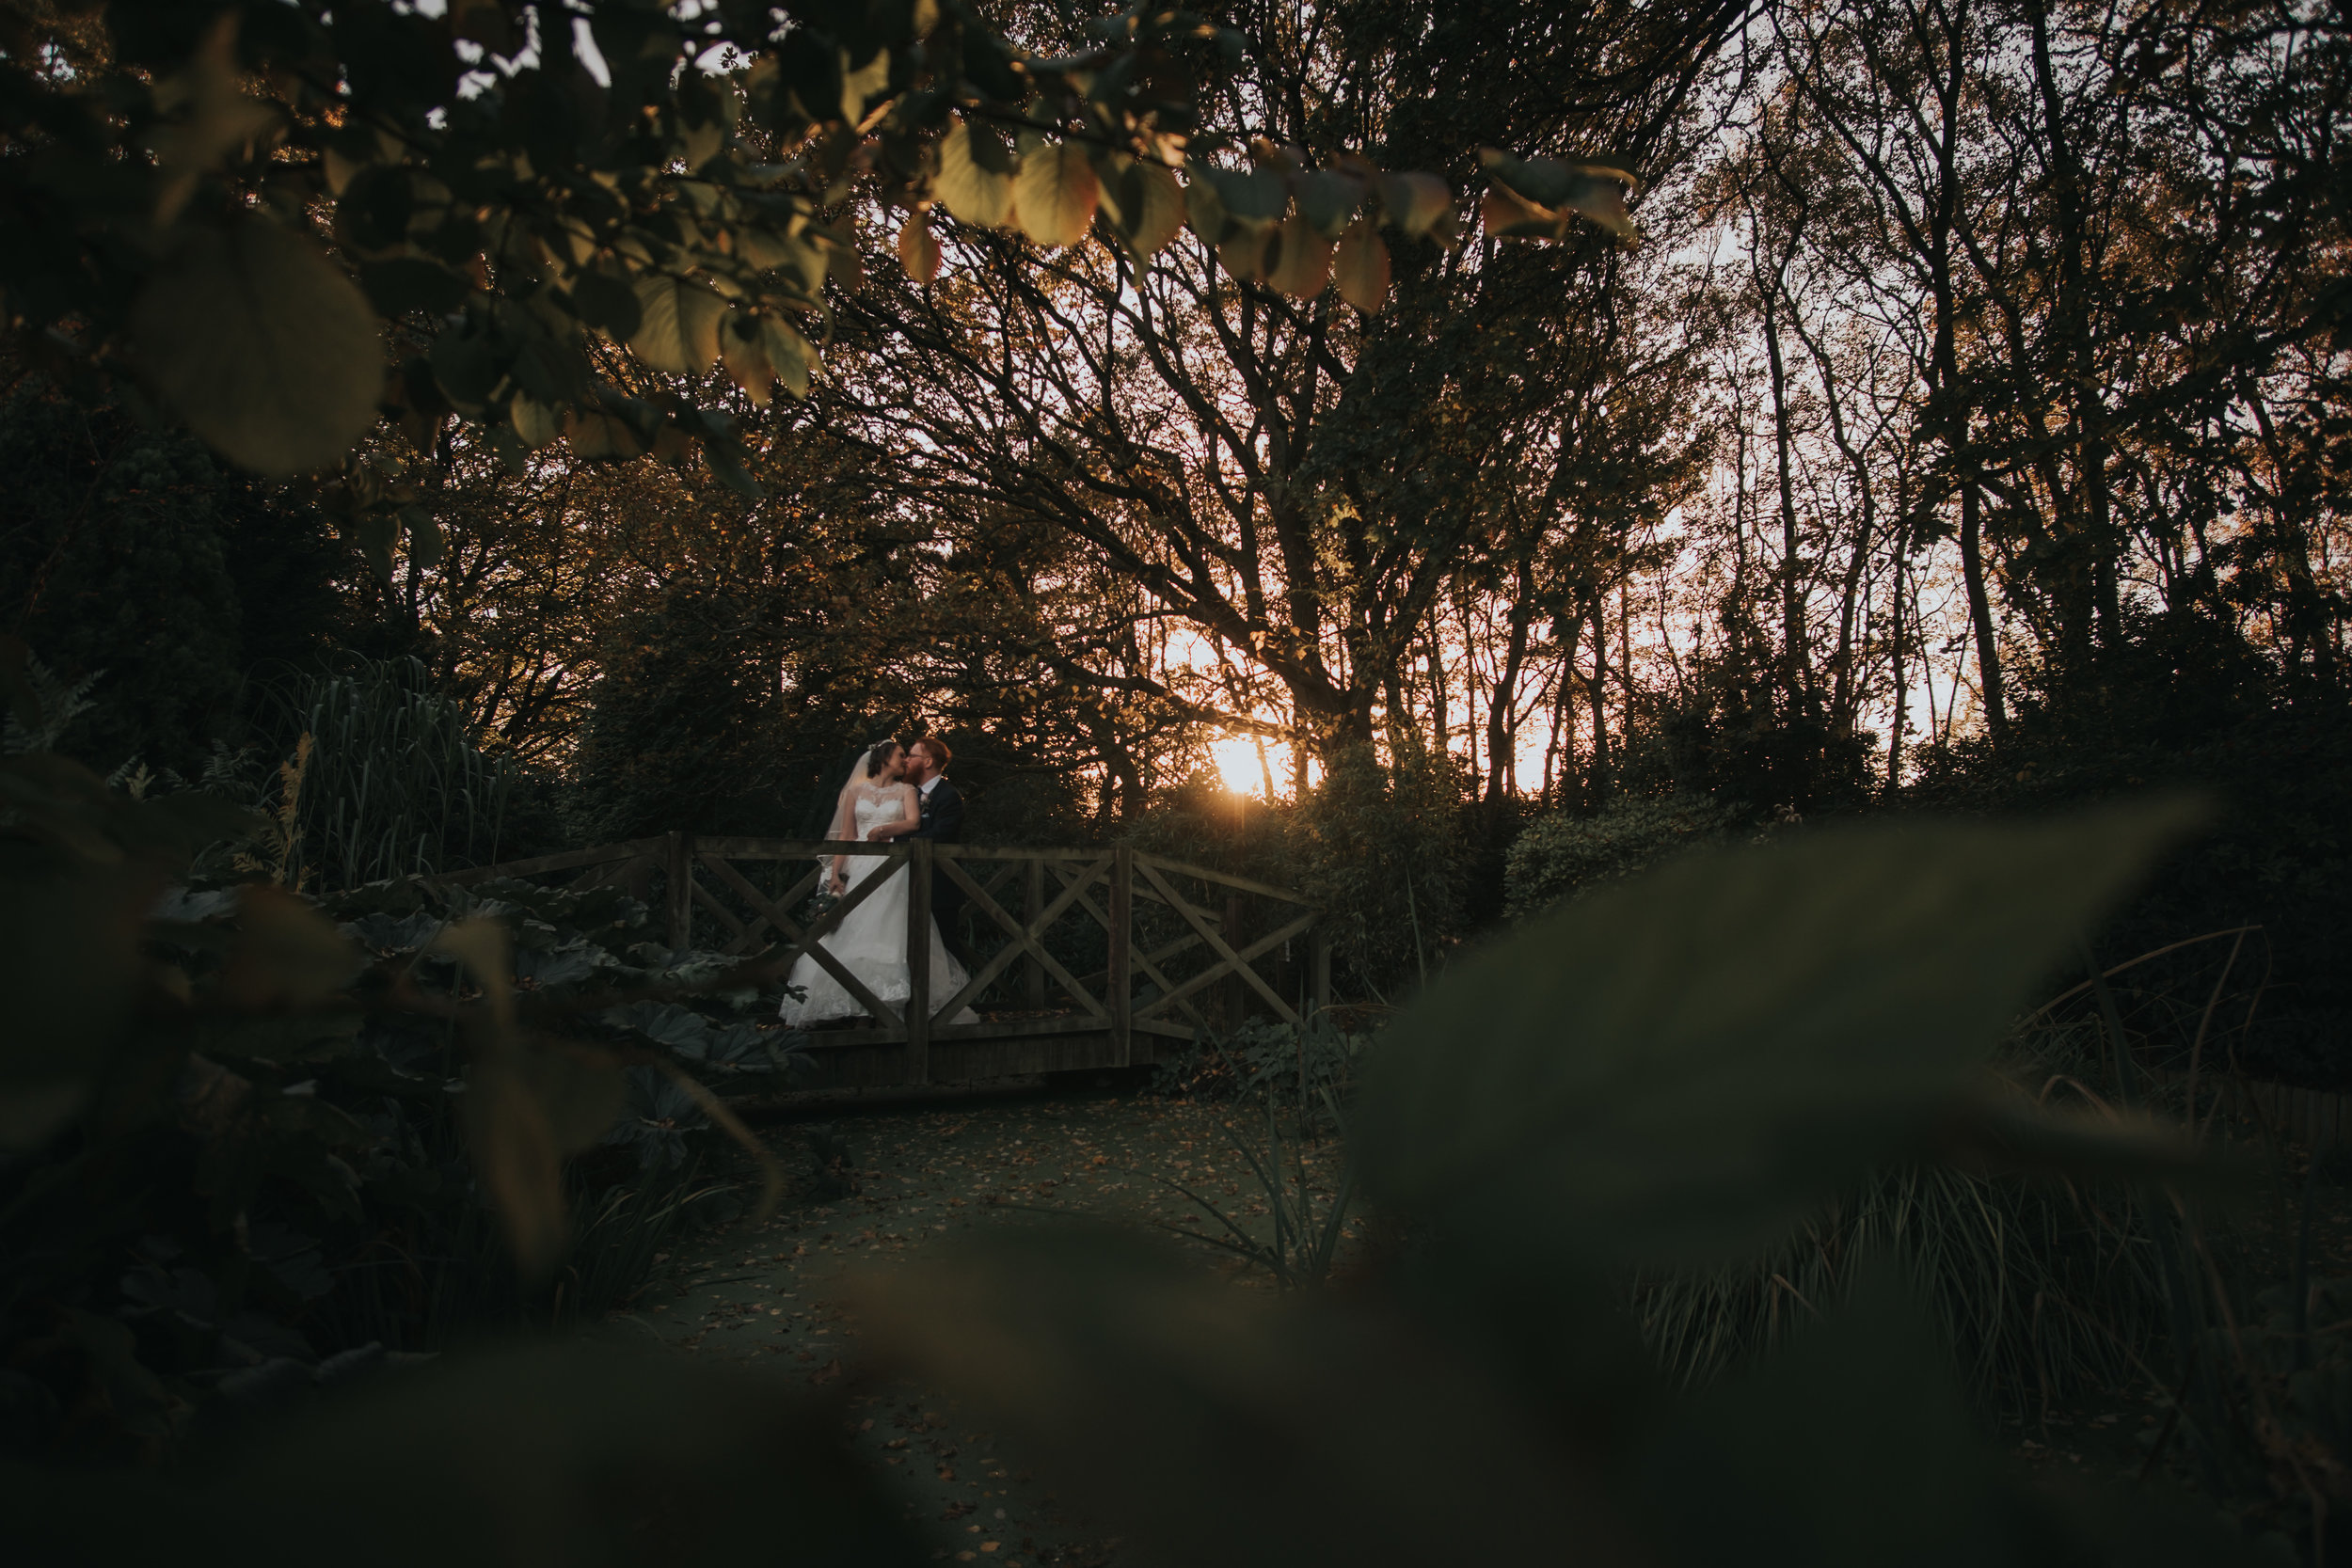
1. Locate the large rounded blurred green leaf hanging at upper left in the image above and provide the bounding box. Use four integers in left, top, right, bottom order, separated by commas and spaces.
132, 216, 384, 475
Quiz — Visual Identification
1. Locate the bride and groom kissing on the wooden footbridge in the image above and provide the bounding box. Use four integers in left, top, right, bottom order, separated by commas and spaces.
776, 736, 978, 1030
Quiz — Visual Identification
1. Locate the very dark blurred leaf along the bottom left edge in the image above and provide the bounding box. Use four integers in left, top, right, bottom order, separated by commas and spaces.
0, 1350, 930, 1568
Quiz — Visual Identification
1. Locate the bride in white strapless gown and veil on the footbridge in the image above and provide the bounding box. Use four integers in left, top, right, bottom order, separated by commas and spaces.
776, 740, 978, 1027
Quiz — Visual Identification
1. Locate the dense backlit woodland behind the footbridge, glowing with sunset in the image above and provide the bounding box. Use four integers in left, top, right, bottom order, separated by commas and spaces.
0, 0, 2352, 1084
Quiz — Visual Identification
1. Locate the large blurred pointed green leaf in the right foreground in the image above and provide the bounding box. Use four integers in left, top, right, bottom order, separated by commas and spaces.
1355, 801, 2197, 1267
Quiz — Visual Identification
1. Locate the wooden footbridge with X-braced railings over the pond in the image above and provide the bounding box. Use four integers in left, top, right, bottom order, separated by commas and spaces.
442, 832, 1331, 1088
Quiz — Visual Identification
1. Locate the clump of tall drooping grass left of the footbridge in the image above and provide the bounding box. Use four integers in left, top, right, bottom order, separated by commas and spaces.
264, 658, 513, 889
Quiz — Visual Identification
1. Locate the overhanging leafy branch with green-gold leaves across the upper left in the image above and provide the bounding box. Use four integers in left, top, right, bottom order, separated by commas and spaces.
0, 0, 1632, 531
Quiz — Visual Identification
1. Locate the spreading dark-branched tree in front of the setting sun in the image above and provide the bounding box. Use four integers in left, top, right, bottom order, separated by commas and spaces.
823, 5, 1731, 770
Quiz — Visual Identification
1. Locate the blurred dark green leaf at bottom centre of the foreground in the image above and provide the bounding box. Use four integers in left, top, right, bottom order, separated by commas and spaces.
859, 1232, 1646, 1568
